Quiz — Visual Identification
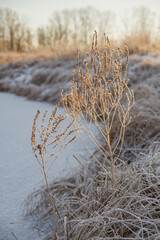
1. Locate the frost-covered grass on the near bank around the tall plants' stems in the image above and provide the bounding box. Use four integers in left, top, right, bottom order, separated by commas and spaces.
24, 88, 160, 240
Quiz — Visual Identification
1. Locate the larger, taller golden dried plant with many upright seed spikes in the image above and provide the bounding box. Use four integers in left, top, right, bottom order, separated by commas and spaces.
62, 31, 134, 192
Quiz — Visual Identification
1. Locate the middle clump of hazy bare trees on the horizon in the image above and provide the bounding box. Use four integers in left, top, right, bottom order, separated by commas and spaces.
37, 7, 115, 48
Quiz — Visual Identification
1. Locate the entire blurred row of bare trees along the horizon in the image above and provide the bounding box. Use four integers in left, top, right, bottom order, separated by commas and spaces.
0, 7, 160, 52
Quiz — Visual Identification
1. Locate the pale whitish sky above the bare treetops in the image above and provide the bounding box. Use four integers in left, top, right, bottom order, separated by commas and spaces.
0, 0, 160, 28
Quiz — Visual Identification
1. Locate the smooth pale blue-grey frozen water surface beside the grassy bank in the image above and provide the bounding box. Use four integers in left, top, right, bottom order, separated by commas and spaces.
0, 93, 96, 240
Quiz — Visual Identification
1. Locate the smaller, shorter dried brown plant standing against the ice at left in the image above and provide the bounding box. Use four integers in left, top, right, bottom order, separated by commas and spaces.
31, 104, 78, 231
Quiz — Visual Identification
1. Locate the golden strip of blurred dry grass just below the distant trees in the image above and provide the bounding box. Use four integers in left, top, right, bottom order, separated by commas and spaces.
0, 39, 160, 65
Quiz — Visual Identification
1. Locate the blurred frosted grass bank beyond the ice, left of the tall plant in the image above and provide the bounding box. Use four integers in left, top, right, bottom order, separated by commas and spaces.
0, 60, 75, 103
